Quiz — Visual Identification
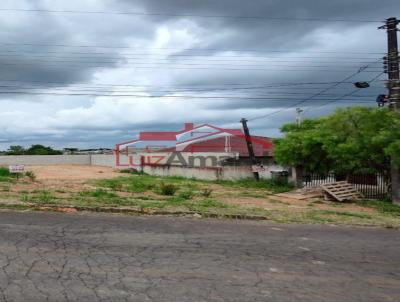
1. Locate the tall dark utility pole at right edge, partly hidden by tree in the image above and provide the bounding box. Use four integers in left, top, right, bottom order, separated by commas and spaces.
380, 18, 400, 204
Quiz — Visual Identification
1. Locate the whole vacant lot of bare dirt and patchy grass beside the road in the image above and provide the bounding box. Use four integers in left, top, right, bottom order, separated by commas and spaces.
0, 165, 400, 227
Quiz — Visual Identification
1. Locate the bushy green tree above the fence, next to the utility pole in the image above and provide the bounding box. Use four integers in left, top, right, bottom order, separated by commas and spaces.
275, 107, 400, 173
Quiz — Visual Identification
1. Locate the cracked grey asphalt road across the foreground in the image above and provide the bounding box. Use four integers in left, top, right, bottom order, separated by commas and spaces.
0, 212, 400, 302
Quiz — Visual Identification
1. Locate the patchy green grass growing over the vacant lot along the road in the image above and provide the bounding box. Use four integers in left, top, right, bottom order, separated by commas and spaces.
0, 170, 400, 227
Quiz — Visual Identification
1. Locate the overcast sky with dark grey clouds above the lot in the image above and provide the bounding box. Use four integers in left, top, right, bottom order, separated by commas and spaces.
0, 0, 400, 150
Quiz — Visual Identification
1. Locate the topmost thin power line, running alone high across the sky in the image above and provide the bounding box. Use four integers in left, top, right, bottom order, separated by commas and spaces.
0, 8, 383, 23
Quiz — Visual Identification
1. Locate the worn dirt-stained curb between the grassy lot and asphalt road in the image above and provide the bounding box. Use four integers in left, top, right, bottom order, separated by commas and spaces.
0, 203, 269, 220
